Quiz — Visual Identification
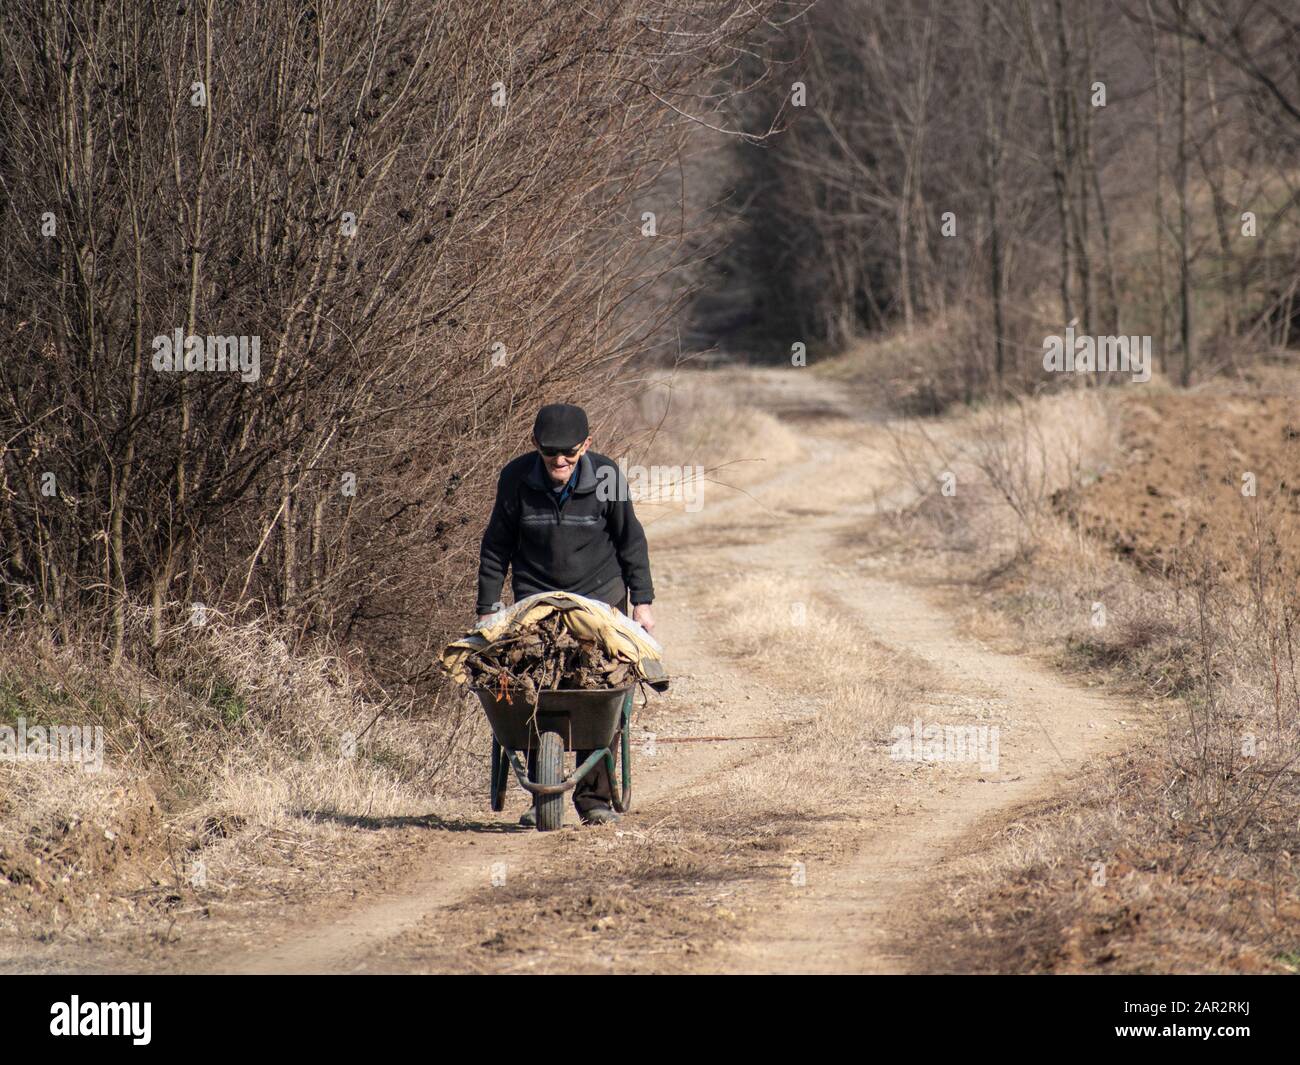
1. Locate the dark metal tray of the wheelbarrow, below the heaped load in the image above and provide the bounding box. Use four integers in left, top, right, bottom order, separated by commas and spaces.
472, 684, 634, 750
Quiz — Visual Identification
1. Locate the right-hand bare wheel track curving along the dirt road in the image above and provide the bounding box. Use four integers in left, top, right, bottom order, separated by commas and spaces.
631, 400, 1140, 973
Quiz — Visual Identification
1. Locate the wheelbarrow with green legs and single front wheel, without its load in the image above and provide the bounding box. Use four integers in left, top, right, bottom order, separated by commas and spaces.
472, 684, 636, 832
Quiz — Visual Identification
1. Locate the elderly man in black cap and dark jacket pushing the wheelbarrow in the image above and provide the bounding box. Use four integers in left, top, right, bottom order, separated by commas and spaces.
477, 403, 654, 824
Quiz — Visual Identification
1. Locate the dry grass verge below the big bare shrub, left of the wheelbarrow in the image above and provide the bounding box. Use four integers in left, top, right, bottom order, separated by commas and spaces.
0, 611, 486, 936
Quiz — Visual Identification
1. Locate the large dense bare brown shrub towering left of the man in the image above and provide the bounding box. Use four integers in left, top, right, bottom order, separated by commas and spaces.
0, 0, 763, 683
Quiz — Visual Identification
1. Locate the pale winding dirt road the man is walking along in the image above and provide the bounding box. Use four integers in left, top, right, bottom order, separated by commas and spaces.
202, 371, 1134, 973
